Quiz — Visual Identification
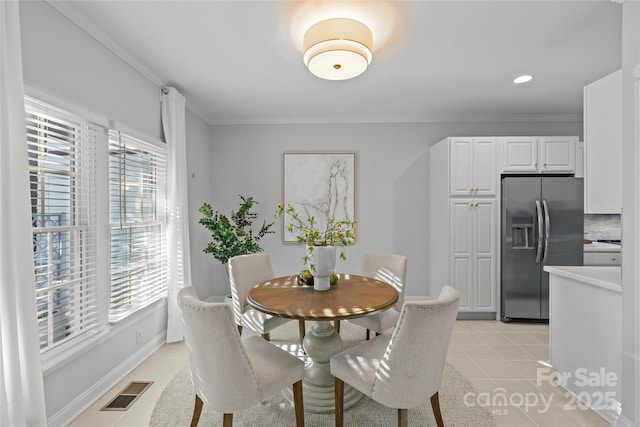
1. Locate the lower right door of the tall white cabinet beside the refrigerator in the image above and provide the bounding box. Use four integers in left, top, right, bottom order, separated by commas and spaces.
473, 199, 497, 311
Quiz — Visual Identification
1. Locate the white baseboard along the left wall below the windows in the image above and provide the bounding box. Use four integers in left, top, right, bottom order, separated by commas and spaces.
47, 331, 167, 427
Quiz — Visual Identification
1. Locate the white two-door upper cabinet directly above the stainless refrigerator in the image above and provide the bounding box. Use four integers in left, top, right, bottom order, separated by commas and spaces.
502, 136, 578, 173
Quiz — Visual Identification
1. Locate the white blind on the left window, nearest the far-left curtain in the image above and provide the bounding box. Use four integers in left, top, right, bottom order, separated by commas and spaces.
25, 97, 105, 351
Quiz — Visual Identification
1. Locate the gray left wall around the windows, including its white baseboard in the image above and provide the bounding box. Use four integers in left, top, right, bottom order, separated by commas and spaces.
20, 1, 211, 425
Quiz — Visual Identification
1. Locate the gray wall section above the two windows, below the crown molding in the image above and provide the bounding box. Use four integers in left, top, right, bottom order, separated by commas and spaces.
20, 1, 162, 140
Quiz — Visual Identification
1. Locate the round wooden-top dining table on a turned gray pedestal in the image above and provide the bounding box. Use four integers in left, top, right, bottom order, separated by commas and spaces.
247, 274, 398, 412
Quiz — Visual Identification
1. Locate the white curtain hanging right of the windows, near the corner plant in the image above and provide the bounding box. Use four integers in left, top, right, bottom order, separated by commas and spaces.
162, 88, 191, 342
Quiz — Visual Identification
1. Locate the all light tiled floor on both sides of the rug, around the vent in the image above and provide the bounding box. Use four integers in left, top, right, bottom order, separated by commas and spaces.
70, 321, 609, 427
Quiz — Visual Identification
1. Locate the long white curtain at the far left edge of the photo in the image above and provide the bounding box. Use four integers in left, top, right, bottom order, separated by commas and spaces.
0, 1, 47, 426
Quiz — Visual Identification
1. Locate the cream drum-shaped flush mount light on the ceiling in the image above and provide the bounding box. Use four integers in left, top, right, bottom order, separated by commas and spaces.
303, 18, 373, 80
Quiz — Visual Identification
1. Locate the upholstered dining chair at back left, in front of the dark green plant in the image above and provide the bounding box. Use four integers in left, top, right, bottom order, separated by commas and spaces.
229, 252, 305, 343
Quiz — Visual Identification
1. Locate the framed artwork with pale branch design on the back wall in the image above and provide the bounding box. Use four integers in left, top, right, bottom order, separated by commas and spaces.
283, 153, 356, 242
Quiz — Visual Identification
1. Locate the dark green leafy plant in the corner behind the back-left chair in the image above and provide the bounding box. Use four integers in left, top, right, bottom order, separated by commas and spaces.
199, 196, 273, 275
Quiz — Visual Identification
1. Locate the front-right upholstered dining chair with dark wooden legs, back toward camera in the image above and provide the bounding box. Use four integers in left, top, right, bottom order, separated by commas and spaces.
330, 286, 460, 427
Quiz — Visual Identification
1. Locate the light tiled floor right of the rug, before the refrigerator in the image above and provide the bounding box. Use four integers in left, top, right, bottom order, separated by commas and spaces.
447, 321, 609, 427
